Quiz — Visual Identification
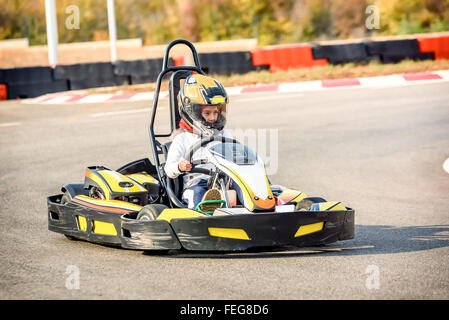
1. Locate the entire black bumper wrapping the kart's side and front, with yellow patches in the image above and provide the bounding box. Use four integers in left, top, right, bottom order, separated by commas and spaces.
47, 195, 354, 251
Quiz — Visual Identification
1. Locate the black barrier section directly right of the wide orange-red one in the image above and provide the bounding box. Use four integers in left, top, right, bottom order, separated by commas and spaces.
312, 42, 371, 64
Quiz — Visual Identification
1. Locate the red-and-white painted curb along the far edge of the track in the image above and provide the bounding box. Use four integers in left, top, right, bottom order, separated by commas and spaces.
21, 70, 449, 104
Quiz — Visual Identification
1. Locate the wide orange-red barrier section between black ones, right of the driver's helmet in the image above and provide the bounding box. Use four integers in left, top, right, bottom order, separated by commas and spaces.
251, 44, 327, 72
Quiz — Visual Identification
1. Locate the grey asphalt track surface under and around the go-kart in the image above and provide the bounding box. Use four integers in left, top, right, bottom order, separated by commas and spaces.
0, 82, 449, 300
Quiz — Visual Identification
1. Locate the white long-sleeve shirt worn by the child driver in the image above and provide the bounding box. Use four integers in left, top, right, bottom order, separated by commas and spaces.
164, 129, 232, 189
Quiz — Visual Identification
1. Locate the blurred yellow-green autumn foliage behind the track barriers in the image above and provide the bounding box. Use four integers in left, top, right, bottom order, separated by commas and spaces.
0, 0, 449, 45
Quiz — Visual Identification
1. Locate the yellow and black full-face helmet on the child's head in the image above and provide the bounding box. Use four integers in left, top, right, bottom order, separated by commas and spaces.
178, 74, 228, 136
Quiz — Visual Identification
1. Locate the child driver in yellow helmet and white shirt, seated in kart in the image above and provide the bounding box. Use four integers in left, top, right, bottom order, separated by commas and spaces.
164, 74, 240, 211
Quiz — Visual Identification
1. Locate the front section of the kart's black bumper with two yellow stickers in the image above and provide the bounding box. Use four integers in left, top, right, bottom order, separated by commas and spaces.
171, 209, 354, 251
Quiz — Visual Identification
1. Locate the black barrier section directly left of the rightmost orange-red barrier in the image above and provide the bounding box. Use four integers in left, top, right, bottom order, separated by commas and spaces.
365, 39, 434, 63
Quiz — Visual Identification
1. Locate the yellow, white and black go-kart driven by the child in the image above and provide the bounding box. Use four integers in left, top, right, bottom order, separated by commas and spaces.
47, 39, 354, 252
